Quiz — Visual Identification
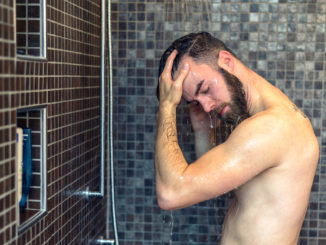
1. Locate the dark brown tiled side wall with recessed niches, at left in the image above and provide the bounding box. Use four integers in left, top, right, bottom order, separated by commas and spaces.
0, 0, 106, 245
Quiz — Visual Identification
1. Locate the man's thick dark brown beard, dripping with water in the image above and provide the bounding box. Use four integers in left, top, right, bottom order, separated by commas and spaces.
210, 67, 250, 144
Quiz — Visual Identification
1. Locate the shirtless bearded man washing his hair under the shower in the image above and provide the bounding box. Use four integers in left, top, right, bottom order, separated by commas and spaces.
155, 33, 319, 245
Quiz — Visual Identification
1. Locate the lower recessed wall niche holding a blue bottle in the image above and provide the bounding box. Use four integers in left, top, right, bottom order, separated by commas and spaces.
16, 107, 47, 233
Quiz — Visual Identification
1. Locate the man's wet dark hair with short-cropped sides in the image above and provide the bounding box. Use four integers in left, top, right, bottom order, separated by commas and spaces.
156, 32, 236, 100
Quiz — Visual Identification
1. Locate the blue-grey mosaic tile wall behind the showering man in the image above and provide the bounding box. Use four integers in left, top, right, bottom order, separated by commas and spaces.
112, 0, 326, 245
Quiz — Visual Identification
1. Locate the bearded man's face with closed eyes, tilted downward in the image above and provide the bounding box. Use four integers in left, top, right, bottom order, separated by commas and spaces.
180, 57, 249, 125
